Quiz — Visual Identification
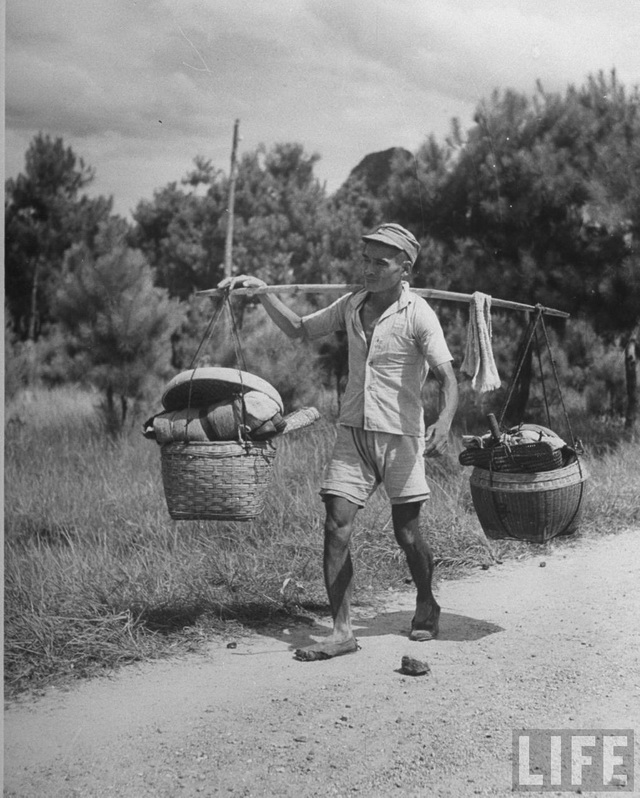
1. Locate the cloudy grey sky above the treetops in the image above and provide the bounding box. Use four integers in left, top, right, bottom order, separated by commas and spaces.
5, 0, 640, 216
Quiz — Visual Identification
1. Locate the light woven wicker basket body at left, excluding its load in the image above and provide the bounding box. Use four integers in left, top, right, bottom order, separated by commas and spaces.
160, 441, 276, 521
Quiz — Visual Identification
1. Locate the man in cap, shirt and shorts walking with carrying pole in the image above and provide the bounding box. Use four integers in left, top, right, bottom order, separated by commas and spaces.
220, 224, 458, 661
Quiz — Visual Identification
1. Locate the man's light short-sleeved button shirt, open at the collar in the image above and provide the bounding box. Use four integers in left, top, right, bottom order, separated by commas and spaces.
302, 282, 453, 436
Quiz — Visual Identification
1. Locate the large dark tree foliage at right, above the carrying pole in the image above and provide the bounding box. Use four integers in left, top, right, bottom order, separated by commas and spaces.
385, 73, 640, 329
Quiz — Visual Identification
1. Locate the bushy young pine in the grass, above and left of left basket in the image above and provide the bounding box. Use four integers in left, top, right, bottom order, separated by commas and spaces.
54, 220, 182, 432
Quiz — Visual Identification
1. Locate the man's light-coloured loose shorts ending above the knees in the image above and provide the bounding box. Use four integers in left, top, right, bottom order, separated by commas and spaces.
320, 426, 429, 507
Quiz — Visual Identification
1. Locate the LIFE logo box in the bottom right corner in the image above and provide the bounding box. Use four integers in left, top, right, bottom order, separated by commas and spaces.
512, 729, 634, 792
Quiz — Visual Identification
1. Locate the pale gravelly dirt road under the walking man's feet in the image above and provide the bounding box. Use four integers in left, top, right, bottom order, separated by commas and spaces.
5, 530, 640, 798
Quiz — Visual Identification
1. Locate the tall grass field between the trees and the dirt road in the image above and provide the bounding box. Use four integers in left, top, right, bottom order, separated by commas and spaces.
5, 389, 640, 696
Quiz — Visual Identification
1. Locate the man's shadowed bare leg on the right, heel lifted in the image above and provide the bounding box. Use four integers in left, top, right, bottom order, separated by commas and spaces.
391, 502, 440, 640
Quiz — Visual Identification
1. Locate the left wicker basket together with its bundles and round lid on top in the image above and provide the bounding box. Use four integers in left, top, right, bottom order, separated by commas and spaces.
148, 367, 320, 521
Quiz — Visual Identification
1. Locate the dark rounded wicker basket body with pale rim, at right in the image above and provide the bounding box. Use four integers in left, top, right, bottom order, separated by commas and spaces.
470, 461, 588, 543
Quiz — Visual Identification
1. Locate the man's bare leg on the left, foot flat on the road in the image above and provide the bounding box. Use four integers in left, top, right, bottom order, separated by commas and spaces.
295, 496, 359, 660
